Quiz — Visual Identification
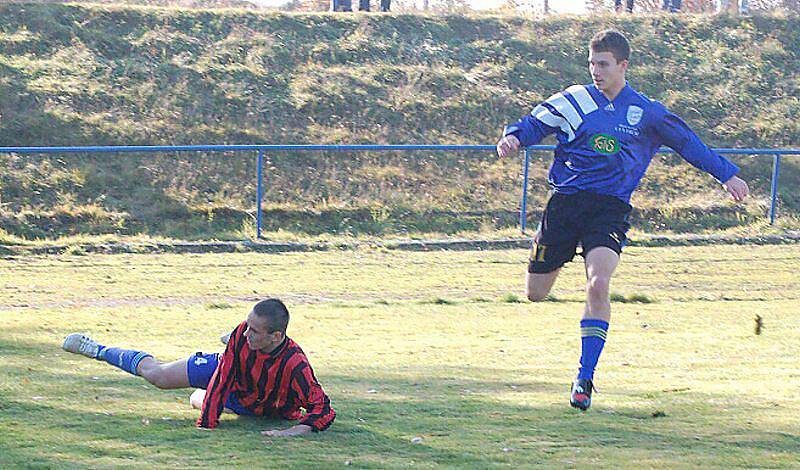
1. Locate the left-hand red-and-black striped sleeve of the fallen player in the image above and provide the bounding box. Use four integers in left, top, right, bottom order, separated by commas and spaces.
197, 322, 247, 429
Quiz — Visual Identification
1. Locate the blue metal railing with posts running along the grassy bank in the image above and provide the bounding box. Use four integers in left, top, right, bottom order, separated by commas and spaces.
0, 145, 800, 238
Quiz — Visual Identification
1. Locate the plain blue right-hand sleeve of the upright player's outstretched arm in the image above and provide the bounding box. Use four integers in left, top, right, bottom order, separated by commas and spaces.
655, 110, 739, 183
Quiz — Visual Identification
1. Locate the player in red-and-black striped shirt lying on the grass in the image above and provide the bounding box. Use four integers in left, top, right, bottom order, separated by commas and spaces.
62, 299, 336, 436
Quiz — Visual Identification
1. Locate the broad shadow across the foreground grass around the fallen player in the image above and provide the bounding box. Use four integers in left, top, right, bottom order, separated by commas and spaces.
0, 338, 800, 468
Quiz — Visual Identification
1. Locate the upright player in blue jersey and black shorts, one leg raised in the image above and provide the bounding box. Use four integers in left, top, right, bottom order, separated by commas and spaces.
497, 30, 748, 410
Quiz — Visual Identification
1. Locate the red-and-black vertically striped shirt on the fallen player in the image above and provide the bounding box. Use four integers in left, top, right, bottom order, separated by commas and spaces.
197, 322, 336, 431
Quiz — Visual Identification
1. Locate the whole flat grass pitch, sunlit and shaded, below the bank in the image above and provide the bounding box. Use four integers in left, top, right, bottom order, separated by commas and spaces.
0, 245, 800, 468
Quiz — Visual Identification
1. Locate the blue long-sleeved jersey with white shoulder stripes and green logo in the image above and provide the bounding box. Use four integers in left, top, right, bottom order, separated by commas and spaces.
504, 84, 739, 202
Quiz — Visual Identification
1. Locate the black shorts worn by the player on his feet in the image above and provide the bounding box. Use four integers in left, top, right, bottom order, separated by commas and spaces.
528, 191, 632, 273
